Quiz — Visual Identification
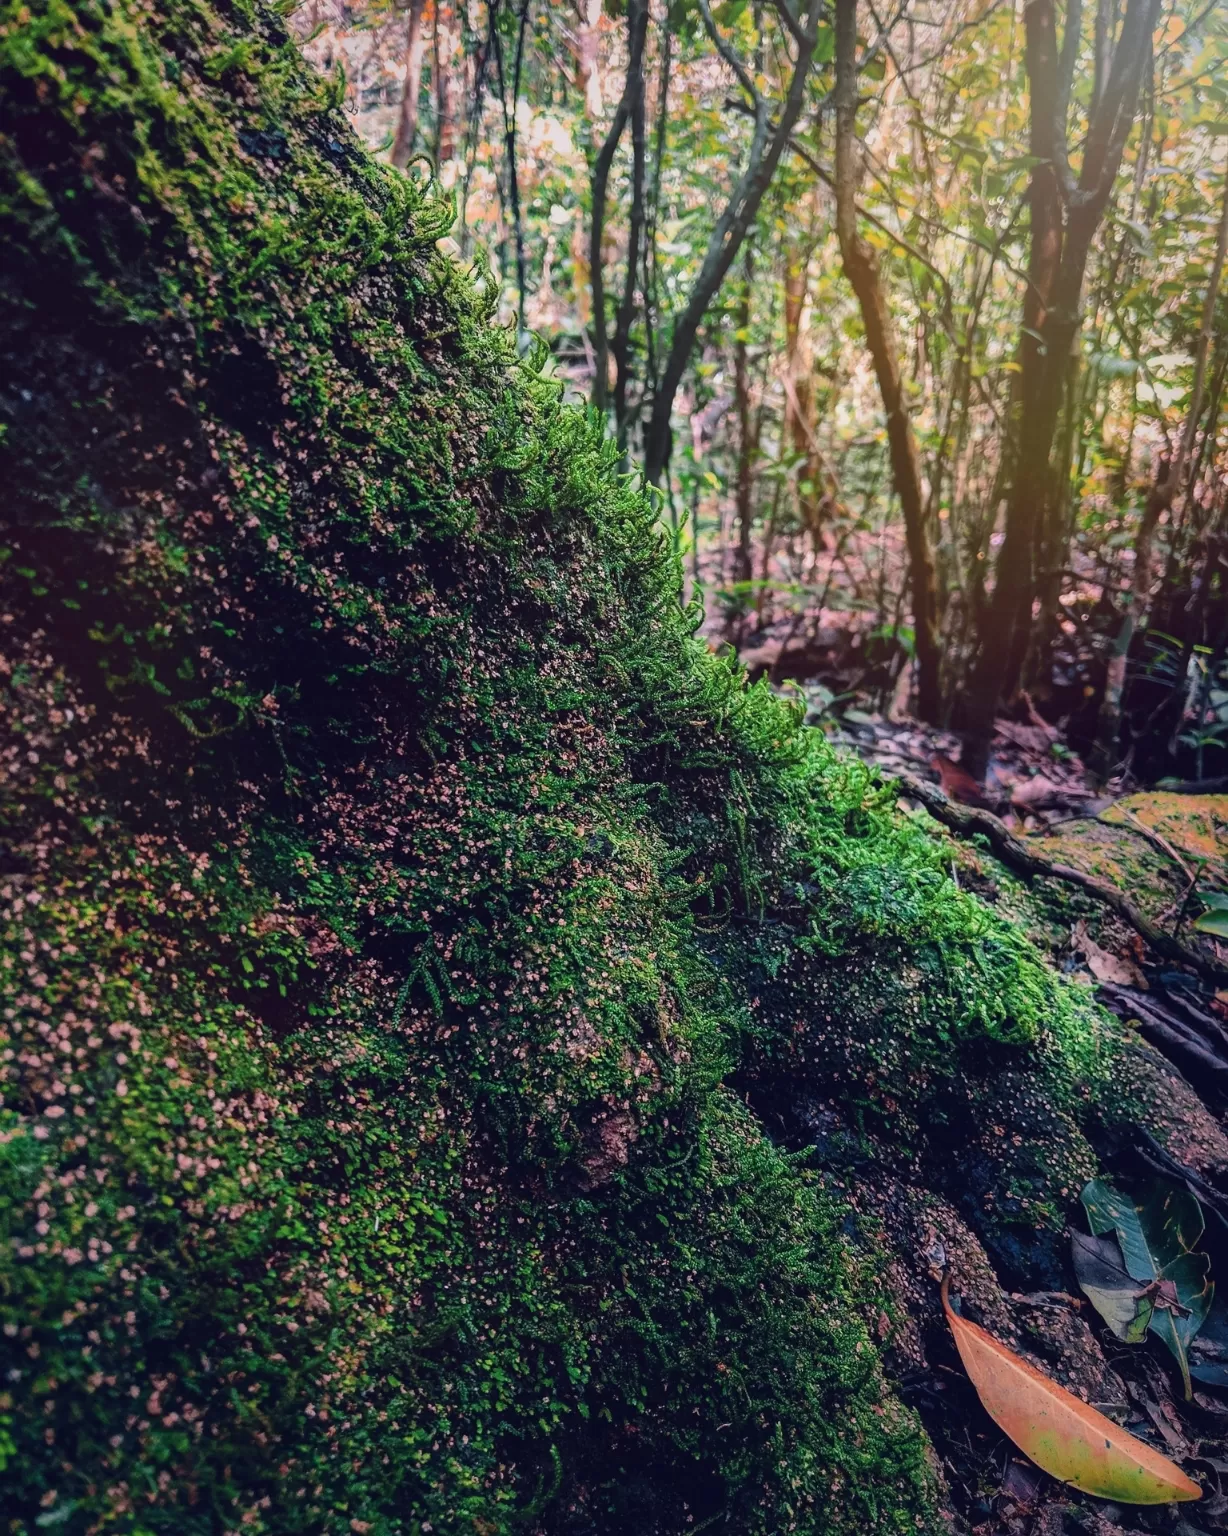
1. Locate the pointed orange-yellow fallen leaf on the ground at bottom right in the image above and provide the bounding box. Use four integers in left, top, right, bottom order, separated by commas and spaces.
942, 1276, 1202, 1504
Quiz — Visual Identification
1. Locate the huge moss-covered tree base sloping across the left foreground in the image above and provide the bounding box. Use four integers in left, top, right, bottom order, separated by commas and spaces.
0, 0, 1228, 1536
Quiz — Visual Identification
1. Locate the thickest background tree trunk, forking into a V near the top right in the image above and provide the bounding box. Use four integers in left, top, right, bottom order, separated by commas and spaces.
964, 0, 1159, 777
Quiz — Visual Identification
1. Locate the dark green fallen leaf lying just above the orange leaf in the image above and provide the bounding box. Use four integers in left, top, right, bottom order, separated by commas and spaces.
1082, 1178, 1216, 1402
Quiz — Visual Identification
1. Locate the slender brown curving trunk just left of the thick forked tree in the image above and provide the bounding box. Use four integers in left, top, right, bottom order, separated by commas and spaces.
836, 0, 942, 723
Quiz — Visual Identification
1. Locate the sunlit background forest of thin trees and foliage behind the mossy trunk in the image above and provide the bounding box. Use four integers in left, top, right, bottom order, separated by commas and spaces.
294, 0, 1228, 780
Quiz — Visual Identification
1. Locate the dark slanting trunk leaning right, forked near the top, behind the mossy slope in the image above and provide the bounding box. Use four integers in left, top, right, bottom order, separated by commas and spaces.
644, 0, 822, 485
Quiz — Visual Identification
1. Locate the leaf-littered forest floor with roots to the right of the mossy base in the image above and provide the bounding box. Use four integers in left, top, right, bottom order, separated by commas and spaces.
709, 580, 1228, 1536
